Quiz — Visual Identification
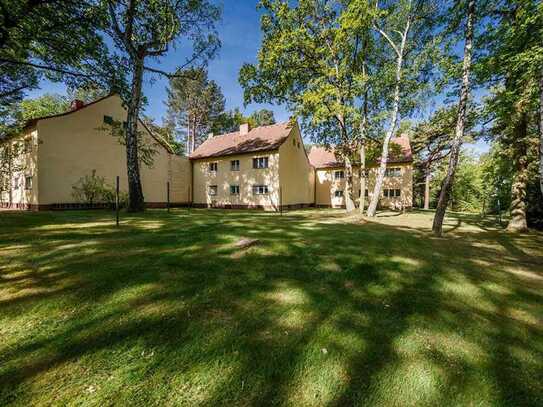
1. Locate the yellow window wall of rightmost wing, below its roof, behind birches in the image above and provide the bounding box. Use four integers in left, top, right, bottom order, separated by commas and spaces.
316, 163, 413, 209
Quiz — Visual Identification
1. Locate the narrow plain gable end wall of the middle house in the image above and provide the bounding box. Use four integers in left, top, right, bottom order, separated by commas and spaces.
279, 125, 315, 206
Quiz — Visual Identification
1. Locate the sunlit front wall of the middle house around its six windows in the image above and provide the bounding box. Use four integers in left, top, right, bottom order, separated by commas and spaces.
192, 150, 279, 210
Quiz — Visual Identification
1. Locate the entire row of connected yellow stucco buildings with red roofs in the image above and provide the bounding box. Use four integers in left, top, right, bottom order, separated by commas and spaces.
0, 95, 413, 210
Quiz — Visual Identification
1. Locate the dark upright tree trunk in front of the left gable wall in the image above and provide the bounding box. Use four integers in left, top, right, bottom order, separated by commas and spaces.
126, 57, 145, 212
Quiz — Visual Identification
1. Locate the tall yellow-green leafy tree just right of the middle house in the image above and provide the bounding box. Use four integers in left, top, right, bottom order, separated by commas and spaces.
240, 0, 373, 211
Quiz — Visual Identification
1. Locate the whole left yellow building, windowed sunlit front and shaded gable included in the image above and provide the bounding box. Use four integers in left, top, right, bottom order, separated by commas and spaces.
0, 95, 190, 210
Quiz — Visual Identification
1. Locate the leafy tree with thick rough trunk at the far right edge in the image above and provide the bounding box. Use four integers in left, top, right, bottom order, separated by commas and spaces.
479, 0, 543, 232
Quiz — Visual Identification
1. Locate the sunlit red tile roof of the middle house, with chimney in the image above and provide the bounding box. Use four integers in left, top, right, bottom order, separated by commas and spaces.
190, 122, 292, 160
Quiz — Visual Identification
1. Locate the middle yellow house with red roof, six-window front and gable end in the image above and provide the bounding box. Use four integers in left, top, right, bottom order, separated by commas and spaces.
190, 122, 315, 210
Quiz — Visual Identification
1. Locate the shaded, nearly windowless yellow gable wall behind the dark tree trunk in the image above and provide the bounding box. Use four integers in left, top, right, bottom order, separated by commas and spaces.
37, 96, 190, 205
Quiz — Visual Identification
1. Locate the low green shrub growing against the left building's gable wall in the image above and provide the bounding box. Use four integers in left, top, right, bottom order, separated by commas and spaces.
72, 171, 128, 207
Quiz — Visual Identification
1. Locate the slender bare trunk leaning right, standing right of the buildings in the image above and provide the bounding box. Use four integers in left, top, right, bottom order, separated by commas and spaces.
432, 0, 475, 236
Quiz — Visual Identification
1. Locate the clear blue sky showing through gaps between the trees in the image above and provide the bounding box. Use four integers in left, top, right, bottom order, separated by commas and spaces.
29, 0, 488, 152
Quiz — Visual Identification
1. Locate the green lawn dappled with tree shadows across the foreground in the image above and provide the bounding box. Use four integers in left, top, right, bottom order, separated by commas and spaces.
0, 210, 543, 406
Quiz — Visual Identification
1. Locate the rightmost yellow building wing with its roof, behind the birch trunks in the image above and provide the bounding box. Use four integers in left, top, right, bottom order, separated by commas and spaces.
309, 136, 413, 210
